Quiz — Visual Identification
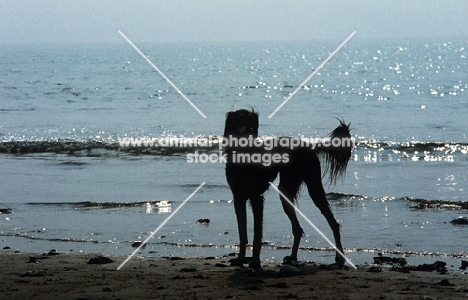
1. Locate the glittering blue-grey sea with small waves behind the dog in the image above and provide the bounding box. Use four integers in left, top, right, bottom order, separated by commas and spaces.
0, 38, 468, 269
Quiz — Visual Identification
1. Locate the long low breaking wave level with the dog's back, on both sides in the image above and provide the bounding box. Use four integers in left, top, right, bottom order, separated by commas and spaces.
0, 136, 468, 162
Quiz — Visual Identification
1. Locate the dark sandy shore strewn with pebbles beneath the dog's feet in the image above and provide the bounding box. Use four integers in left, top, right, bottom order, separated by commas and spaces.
0, 250, 468, 299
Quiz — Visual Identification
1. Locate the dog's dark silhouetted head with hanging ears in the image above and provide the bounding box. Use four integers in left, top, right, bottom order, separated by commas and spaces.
224, 109, 258, 138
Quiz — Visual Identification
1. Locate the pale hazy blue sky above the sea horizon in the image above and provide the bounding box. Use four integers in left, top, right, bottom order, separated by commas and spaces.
0, 0, 468, 44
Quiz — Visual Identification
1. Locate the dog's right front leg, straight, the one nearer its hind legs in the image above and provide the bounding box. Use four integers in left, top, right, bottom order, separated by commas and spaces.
249, 195, 264, 269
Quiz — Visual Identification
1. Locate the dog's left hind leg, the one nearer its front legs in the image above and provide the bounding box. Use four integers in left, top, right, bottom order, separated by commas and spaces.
278, 180, 304, 264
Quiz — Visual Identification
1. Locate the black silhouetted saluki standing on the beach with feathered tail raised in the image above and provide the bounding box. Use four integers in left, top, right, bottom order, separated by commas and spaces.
223, 109, 352, 269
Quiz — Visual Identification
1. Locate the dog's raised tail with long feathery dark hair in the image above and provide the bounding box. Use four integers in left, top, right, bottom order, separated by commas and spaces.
319, 119, 354, 184
